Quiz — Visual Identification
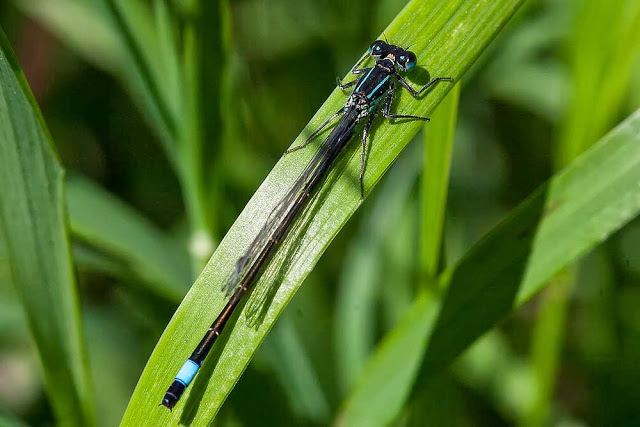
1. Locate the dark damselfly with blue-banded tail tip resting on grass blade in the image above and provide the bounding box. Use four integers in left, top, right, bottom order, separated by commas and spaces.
161, 40, 451, 409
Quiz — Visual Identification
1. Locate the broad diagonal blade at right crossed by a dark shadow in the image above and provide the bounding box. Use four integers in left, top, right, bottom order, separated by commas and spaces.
339, 111, 640, 425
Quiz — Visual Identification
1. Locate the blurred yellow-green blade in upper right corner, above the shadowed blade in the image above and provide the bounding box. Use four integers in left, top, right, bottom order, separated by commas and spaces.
557, 0, 640, 166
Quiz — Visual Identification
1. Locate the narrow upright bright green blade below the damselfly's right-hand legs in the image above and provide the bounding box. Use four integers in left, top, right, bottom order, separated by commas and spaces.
420, 83, 460, 280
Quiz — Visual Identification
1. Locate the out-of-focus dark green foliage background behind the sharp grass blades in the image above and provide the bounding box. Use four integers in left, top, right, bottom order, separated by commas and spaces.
0, 0, 640, 426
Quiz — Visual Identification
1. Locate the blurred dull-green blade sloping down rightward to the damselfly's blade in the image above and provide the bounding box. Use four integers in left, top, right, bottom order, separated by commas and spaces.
67, 176, 191, 301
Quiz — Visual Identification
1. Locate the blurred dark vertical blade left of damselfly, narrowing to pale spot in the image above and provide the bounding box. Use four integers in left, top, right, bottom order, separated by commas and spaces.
180, 0, 231, 271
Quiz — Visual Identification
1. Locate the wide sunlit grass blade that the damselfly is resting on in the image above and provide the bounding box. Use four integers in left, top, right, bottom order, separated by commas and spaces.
123, 0, 522, 425
